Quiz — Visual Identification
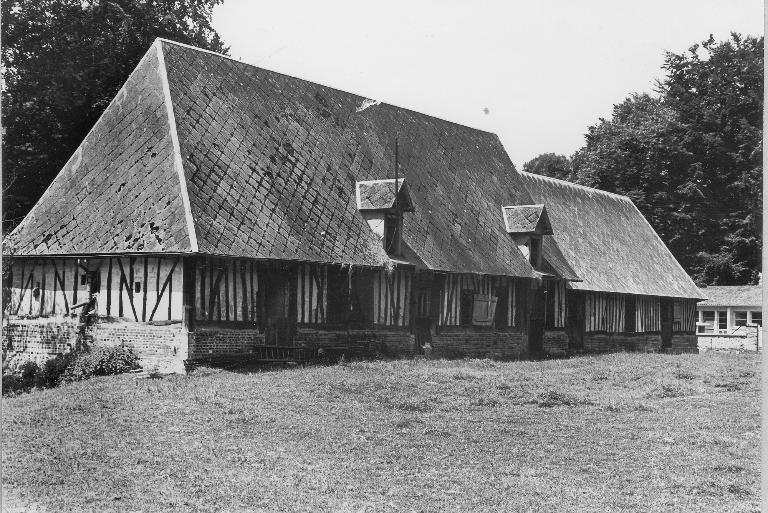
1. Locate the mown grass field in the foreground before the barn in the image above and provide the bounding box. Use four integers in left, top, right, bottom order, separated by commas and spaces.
2, 353, 760, 513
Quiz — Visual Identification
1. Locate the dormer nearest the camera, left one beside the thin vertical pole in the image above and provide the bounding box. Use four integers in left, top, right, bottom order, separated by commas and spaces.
356, 178, 414, 256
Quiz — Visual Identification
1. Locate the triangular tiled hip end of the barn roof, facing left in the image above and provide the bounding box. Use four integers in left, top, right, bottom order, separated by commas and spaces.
5, 45, 194, 255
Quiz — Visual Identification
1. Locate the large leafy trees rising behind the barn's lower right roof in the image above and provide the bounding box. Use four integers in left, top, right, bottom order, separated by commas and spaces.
526, 34, 763, 285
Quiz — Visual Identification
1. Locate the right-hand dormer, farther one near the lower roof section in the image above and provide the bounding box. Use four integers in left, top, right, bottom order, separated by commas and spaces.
502, 205, 552, 269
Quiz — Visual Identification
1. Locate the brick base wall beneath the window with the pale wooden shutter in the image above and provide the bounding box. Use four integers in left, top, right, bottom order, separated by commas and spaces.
431, 328, 528, 360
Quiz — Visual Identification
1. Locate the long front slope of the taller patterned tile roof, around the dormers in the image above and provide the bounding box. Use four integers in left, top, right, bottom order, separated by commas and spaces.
162, 42, 533, 277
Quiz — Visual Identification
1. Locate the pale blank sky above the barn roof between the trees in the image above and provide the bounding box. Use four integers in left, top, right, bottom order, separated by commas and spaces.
213, 0, 763, 169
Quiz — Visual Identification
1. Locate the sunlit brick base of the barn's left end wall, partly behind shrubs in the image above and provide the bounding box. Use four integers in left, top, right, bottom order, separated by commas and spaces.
2, 318, 188, 372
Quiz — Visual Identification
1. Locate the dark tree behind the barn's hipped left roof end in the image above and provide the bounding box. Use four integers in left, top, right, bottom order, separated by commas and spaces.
1, 0, 228, 232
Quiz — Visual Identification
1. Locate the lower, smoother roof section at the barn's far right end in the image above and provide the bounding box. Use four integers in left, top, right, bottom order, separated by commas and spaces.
520, 173, 704, 298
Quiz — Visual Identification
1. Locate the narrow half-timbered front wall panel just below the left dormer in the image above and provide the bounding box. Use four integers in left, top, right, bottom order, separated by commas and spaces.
373, 270, 412, 326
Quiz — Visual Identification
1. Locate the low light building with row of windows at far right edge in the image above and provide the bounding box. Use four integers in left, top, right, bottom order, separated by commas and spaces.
696, 285, 763, 351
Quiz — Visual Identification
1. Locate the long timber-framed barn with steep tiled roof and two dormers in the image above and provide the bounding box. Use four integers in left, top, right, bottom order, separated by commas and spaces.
3, 40, 703, 371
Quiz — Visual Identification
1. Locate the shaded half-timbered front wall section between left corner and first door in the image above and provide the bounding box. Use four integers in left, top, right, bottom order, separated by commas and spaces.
195, 257, 259, 323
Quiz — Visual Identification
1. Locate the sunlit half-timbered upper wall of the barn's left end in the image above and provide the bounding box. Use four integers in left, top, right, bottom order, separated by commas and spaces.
5, 256, 183, 322
